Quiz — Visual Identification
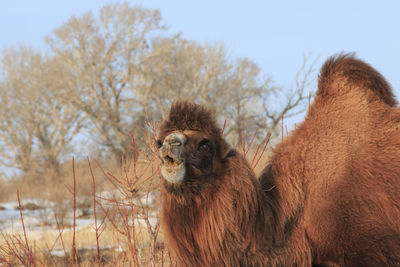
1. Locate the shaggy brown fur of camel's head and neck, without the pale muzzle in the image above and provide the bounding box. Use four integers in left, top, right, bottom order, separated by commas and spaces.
158, 102, 286, 266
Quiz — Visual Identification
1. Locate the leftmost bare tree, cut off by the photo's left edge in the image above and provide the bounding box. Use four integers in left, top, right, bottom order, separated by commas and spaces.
0, 47, 82, 174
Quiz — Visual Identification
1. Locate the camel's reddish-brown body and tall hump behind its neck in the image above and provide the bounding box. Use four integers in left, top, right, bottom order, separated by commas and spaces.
260, 55, 400, 266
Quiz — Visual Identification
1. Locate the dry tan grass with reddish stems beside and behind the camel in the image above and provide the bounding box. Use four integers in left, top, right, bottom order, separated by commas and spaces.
0, 129, 269, 266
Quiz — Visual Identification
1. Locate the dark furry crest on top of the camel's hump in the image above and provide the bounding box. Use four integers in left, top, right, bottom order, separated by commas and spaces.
317, 54, 397, 107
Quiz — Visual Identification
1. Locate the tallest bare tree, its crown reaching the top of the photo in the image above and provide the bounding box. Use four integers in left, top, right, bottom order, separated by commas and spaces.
47, 4, 163, 159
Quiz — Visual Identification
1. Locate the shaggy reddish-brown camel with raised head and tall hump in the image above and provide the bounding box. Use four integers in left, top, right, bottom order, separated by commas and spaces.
157, 55, 400, 266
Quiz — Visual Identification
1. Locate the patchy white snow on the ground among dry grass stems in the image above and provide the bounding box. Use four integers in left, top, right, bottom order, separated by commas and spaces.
0, 192, 158, 262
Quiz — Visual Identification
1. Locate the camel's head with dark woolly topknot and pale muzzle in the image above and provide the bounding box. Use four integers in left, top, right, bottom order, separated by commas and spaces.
157, 101, 231, 186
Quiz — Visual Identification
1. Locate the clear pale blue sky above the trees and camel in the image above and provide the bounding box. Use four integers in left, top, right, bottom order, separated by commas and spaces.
0, 0, 400, 107
